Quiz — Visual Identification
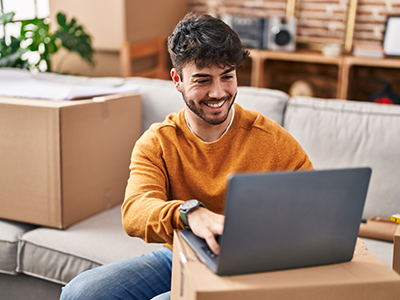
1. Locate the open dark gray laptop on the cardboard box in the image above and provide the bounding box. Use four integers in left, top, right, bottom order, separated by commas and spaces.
180, 168, 371, 275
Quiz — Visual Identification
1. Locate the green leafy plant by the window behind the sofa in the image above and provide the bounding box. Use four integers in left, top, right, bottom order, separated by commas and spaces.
0, 12, 95, 72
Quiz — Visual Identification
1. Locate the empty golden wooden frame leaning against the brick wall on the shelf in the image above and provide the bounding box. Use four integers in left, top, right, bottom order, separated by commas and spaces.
286, 0, 358, 53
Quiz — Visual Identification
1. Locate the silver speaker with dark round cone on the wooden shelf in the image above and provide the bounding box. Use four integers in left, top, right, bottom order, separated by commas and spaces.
263, 18, 297, 52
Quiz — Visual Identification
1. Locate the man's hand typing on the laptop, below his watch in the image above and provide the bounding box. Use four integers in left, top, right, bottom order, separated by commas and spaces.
187, 207, 225, 255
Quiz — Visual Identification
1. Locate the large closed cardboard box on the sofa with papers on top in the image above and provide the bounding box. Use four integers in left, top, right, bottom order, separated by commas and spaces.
0, 93, 141, 228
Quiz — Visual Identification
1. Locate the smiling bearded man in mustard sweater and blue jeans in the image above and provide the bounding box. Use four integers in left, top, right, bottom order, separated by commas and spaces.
62, 13, 312, 299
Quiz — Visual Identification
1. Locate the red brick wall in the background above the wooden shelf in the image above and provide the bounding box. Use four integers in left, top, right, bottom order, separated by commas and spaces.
188, 0, 400, 44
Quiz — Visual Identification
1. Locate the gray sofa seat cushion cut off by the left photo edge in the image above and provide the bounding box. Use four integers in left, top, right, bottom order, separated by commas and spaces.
0, 220, 35, 275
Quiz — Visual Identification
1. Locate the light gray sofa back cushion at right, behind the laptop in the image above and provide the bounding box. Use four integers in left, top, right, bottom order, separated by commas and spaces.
284, 97, 400, 219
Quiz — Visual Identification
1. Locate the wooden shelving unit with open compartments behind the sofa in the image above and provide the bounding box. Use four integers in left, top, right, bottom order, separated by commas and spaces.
249, 49, 400, 100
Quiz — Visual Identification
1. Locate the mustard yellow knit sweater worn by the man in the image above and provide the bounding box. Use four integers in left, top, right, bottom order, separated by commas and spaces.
122, 104, 313, 249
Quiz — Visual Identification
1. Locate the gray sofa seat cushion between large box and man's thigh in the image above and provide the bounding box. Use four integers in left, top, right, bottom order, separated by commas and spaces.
18, 206, 161, 284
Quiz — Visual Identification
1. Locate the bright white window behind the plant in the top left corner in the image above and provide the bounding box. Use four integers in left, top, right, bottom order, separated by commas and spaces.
0, 0, 50, 39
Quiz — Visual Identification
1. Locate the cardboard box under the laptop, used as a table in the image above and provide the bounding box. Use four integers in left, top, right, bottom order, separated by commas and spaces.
171, 231, 400, 300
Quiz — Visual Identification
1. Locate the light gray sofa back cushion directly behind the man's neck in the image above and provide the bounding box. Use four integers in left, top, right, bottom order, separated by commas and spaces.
127, 77, 289, 132
